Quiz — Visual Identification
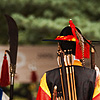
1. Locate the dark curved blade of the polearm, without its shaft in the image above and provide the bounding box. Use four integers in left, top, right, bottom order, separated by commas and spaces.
5, 15, 18, 65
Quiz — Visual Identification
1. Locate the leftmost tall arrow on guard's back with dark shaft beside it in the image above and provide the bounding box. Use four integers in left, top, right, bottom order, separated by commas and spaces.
57, 47, 68, 100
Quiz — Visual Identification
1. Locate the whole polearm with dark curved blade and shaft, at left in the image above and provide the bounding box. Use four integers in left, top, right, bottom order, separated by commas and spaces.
5, 15, 18, 100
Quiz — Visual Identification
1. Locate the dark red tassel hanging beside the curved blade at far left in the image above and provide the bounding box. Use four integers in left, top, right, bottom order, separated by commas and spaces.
0, 52, 10, 87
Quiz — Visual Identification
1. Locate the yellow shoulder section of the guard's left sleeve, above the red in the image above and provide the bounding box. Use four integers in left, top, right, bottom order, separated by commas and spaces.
40, 73, 51, 97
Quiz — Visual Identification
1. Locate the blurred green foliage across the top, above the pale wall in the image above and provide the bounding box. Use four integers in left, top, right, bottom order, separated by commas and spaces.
0, 0, 100, 44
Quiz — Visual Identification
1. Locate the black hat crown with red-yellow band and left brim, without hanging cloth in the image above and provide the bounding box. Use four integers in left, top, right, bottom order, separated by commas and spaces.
43, 20, 81, 42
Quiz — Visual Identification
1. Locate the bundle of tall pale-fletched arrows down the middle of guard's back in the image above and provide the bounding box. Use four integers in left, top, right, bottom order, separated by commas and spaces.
55, 47, 77, 100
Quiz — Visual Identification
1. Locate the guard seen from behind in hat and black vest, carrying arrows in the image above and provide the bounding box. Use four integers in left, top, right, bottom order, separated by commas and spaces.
36, 20, 100, 100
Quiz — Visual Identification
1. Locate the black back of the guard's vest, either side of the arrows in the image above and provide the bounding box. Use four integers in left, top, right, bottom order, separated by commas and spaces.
46, 66, 96, 100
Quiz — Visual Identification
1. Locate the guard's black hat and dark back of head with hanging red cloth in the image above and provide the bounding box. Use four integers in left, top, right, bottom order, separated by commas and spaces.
44, 20, 90, 59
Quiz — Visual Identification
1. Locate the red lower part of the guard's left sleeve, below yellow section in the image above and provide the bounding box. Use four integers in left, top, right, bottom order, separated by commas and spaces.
36, 86, 51, 100
